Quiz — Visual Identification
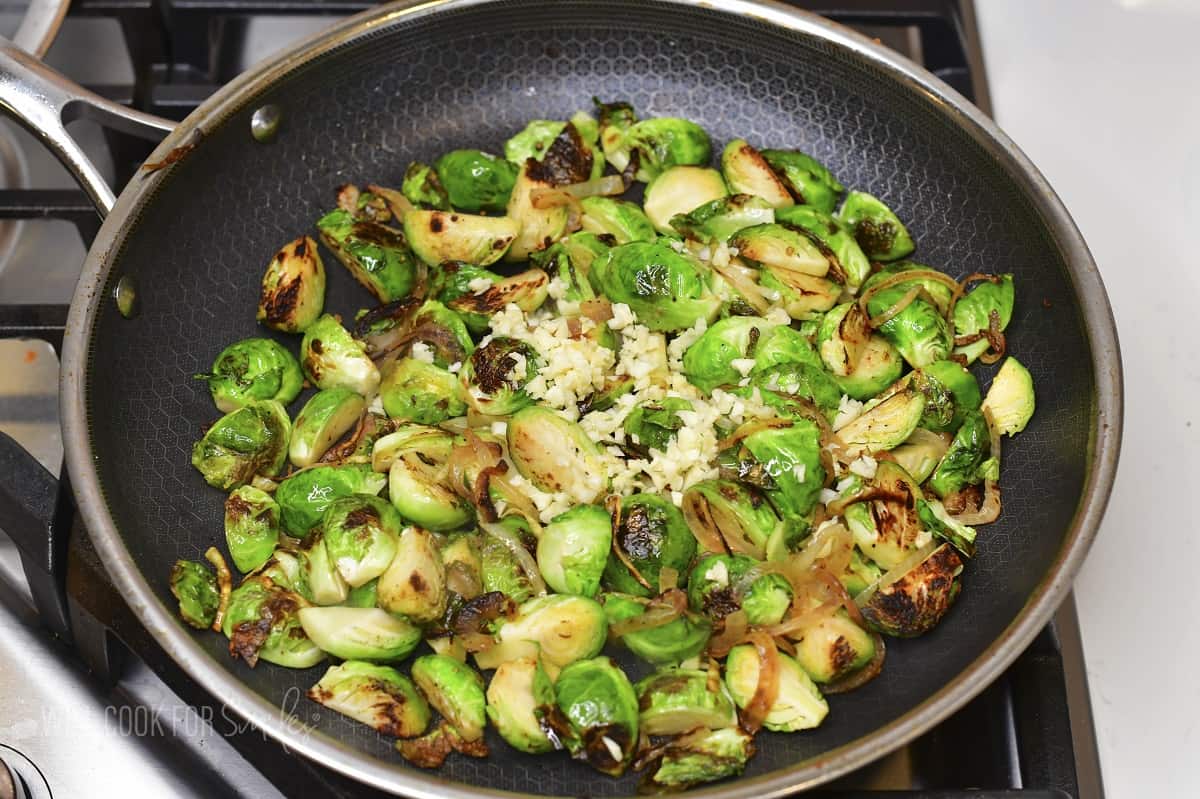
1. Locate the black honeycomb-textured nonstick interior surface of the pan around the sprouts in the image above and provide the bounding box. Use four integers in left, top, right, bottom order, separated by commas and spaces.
86, 0, 1096, 797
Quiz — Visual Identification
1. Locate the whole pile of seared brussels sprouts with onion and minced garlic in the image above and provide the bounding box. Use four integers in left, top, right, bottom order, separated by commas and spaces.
169, 100, 1036, 792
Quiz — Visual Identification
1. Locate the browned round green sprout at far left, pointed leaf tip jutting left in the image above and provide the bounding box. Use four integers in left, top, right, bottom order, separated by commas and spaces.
196, 338, 304, 414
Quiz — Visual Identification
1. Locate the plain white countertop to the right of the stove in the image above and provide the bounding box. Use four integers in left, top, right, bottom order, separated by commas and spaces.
976, 0, 1200, 798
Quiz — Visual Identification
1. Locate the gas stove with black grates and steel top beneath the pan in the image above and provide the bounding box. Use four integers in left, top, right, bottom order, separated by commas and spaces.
0, 0, 1103, 799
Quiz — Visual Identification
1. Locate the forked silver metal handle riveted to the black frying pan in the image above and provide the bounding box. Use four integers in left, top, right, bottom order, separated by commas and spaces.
0, 38, 175, 217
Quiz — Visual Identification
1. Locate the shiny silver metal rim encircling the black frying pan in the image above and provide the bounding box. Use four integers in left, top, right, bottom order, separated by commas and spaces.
60, 0, 1123, 799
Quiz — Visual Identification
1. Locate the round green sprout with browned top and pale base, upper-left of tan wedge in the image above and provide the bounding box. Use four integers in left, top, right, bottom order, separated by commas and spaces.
322, 494, 404, 588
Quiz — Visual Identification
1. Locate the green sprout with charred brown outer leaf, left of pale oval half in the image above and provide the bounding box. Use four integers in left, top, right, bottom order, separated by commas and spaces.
222, 577, 325, 668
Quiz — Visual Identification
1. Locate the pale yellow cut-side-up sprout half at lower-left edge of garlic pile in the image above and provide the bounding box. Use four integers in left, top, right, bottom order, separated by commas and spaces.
508, 405, 608, 503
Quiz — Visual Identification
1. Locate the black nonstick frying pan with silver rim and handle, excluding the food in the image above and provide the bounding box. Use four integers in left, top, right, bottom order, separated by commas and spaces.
0, 0, 1121, 799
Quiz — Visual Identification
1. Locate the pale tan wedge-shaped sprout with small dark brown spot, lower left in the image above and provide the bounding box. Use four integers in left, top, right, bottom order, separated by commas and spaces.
378, 527, 448, 624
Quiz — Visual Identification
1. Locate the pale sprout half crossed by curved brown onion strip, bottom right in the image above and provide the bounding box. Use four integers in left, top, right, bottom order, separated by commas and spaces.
725, 644, 829, 732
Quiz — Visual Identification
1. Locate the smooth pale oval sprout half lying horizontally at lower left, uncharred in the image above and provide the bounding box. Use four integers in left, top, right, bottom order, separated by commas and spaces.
300, 607, 421, 661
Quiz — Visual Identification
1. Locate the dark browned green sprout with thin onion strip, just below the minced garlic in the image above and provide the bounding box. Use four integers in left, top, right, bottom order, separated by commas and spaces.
604, 494, 696, 596
